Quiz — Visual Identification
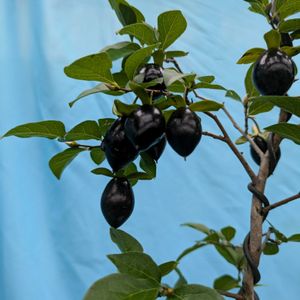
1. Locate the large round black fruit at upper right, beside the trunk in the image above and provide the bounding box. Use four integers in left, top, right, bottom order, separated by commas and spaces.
252, 49, 295, 96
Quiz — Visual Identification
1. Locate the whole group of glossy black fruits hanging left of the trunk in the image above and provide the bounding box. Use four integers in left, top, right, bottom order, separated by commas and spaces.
101, 64, 202, 228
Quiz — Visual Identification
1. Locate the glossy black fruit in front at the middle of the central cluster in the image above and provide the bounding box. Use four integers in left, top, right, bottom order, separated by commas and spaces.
125, 104, 166, 151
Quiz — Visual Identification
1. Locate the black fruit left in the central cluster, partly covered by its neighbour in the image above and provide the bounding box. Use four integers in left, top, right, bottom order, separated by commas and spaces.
101, 118, 138, 172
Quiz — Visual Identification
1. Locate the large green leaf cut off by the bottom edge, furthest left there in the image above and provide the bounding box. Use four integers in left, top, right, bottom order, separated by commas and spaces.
84, 274, 160, 300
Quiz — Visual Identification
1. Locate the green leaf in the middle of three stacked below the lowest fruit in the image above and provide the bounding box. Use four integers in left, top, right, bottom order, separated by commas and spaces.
108, 252, 161, 283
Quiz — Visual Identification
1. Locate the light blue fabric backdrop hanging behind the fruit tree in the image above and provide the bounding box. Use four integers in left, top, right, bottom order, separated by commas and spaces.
0, 0, 300, 300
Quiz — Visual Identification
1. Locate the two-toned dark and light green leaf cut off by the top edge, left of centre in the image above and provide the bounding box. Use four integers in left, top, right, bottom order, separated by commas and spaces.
109, 0, 145, 26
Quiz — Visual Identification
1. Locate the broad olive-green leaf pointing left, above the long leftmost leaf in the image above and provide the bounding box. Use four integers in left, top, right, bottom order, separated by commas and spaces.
64, 52, 115, 85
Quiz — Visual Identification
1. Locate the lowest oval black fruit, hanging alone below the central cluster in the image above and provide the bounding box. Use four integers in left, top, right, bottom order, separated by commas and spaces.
101, 178, 134, 228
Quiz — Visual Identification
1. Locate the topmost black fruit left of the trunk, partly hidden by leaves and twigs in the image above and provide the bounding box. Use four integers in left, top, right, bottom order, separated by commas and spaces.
140, 64, 166, 99
